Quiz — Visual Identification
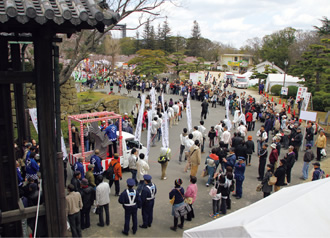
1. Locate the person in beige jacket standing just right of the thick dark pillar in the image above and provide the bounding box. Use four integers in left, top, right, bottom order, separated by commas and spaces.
65, 184, 83, 237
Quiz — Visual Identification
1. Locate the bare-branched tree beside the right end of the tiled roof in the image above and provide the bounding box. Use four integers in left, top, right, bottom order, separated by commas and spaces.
60, 0, 175, 85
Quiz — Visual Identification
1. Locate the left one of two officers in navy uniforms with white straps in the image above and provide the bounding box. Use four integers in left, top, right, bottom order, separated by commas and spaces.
118, 178, 141, 235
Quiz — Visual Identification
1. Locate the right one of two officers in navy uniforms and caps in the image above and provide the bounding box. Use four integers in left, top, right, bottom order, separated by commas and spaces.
140, 174, 157, 228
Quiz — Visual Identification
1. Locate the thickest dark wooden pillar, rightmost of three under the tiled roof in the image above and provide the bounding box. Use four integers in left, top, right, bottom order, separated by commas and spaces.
33, 28, 66, 237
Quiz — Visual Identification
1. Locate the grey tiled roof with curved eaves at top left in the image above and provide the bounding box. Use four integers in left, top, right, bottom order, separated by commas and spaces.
0, 0, 119, 33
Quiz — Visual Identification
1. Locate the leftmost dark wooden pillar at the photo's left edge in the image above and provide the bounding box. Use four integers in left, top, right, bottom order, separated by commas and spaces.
0, 38, 22, 237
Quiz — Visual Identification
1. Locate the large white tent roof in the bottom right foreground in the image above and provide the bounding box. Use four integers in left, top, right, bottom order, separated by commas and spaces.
183, 178, 330, 238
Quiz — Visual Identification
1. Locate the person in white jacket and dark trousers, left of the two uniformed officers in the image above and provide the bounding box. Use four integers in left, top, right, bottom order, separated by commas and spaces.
95, 175, 110, 227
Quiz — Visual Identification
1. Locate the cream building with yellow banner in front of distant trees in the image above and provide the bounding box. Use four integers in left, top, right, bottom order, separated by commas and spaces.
220, 54, 253, 74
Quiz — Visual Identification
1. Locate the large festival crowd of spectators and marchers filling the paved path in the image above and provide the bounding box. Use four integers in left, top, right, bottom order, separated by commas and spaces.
16, 73, 326, 237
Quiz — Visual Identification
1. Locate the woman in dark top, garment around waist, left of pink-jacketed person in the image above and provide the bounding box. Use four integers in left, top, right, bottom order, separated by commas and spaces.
169, 179, 187, 231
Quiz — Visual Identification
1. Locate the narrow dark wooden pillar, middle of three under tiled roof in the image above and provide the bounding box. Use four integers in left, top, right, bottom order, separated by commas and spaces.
10, 44, 27, 145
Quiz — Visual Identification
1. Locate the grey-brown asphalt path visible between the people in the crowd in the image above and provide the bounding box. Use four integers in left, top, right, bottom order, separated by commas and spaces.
78, 86, 311, 237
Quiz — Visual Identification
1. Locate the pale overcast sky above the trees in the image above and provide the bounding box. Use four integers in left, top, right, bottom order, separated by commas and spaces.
119, 0, 330, 47
